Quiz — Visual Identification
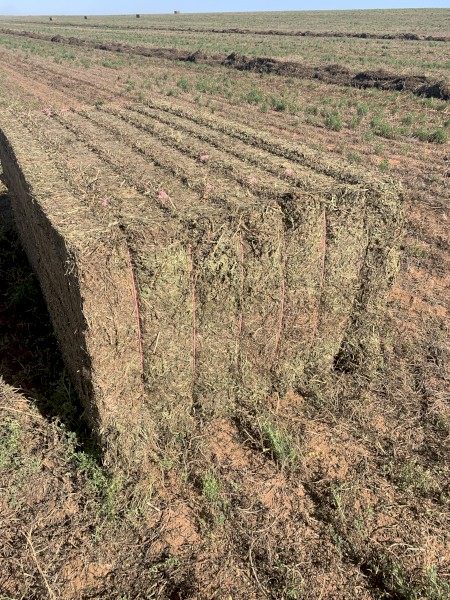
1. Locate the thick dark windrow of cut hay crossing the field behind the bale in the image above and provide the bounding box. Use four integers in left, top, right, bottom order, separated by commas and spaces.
0, 29, 450, 100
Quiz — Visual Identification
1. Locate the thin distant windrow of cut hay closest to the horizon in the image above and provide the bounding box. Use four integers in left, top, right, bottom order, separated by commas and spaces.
11, 21, 450, 42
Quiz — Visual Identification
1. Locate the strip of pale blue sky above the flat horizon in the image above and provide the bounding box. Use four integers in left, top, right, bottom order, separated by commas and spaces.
0, 0, 450, 15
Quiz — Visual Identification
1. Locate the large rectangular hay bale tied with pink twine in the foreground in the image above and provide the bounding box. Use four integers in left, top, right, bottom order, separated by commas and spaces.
0, 103, 401, 468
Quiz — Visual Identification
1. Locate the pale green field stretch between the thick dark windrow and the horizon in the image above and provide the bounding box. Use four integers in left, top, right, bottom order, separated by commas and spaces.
0, 10, 450, 81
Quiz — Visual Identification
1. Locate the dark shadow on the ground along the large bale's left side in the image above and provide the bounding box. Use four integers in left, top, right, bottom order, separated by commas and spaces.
0, 191, 84, 431
